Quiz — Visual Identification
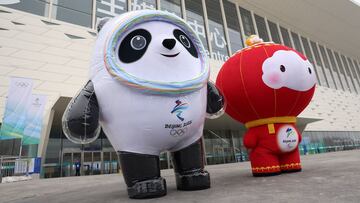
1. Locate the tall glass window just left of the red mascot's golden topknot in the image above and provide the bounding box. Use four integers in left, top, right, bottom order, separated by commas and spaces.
223, 0, 244, 53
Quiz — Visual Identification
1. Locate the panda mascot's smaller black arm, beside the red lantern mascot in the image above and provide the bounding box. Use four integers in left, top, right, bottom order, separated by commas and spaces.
206, 81, 225, 118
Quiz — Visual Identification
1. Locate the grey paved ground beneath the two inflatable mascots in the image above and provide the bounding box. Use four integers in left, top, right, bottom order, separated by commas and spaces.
0, 150, 360, 203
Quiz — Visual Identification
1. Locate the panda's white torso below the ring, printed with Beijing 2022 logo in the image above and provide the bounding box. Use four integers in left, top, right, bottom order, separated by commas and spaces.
92, 68, 206, 155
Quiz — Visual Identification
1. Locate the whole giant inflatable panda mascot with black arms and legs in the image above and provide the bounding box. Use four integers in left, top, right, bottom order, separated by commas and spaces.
62, 10, 224, 199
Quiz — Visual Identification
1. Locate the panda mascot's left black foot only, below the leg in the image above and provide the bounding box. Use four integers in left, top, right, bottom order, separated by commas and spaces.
127, 177, 166, 199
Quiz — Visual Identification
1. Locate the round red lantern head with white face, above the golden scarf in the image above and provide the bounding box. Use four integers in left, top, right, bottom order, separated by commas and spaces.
216, 43, 316, 123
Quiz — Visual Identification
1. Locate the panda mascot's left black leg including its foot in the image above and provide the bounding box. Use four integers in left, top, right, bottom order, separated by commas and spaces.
119, 151, 166, 199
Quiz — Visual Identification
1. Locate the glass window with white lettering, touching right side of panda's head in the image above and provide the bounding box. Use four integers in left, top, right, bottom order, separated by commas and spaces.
185, 0, 209, 55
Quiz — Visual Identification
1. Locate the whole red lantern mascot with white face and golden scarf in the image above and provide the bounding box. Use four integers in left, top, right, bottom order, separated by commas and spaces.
216, 36, 316, 176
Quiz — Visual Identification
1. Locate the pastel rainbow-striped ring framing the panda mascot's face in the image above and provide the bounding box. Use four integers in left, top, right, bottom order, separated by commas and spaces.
104, 10, 210, 94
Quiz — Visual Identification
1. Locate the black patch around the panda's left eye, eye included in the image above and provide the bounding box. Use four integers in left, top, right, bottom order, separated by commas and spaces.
118, 29, 151, 63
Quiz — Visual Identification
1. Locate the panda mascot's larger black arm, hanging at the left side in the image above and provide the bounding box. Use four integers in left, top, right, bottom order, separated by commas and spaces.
62, 80, 100, 144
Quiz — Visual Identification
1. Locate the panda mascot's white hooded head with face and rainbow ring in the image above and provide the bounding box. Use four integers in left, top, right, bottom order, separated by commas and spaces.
91, 10, 209, 94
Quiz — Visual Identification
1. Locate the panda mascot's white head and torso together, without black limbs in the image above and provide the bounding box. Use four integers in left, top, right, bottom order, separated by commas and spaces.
90, 11, 209, 155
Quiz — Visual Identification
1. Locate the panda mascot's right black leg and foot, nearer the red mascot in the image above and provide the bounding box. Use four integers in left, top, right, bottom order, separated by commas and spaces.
172, 139, 210, 190
